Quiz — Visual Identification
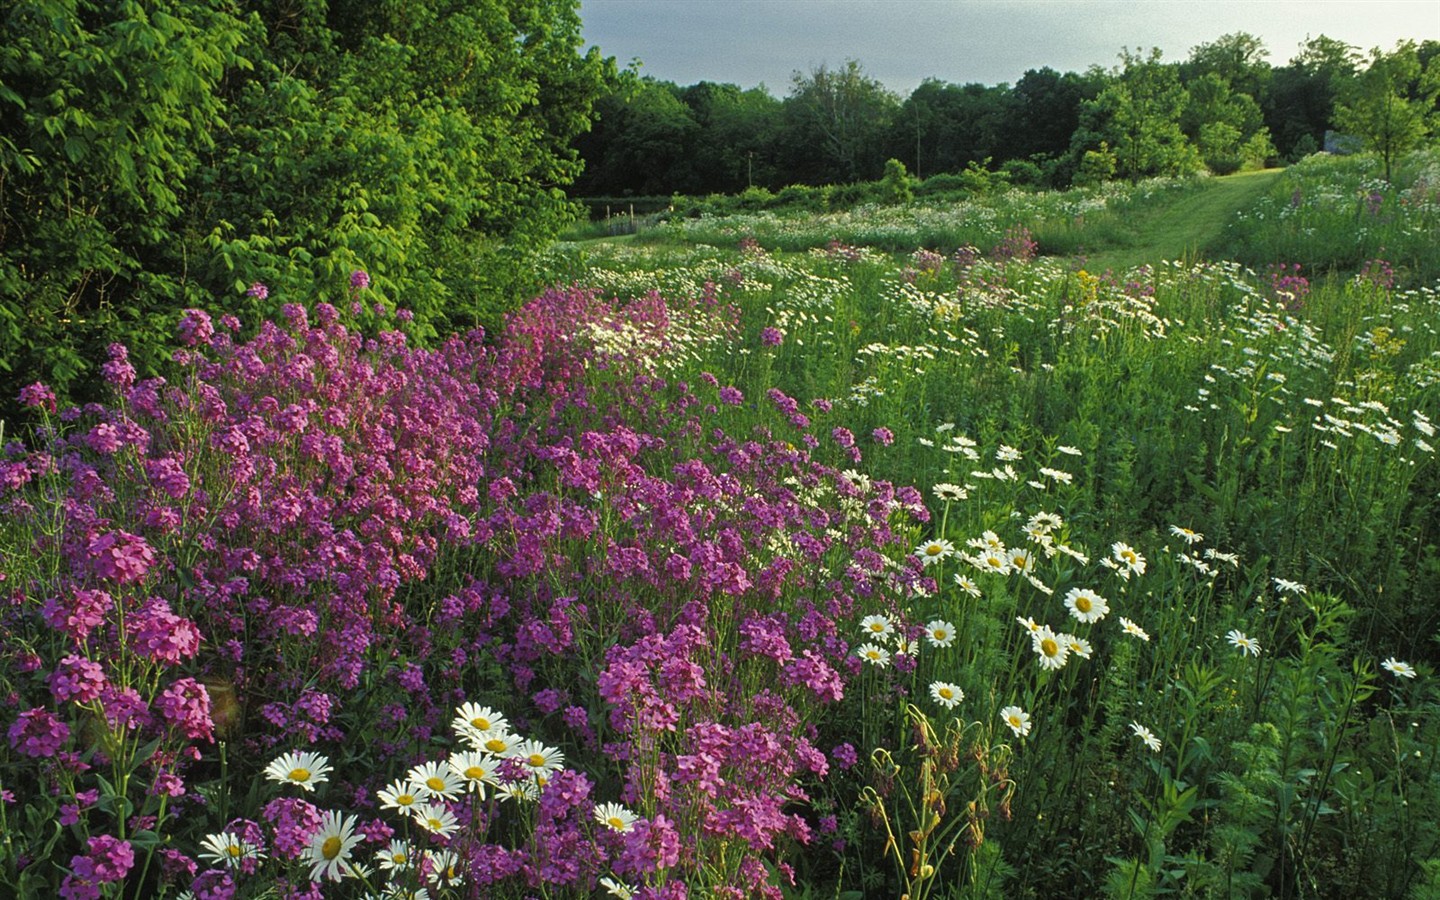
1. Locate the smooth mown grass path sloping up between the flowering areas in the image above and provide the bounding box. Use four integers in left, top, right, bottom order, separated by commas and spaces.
1086, 168, 1282, 271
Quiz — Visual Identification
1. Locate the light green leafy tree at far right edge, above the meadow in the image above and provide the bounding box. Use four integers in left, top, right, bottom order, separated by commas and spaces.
1335, 40, 1440, 181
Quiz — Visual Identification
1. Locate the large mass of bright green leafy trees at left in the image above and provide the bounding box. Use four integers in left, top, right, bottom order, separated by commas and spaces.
0, 0, 612, 403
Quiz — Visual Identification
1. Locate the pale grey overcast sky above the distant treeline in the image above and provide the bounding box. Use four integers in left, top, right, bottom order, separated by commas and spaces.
580, 0, 1440, 96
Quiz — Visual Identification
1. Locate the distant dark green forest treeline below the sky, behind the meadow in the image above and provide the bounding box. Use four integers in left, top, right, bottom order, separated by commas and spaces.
570, 32, 1440, 197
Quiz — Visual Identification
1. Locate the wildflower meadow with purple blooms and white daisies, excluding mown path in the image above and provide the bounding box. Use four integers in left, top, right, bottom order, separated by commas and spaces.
0, 153, 1440, 900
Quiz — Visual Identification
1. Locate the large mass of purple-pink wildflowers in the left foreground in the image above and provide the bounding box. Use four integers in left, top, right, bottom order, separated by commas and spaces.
0, 281, 933, 897
